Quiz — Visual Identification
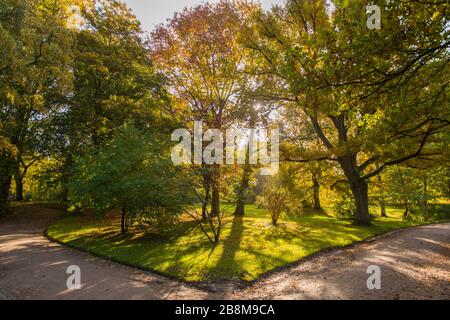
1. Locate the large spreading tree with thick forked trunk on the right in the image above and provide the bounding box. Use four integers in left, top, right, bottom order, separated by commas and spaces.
247, 0, 450, 225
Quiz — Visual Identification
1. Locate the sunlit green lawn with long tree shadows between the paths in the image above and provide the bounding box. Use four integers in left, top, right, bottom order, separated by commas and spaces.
47, 206, 424, 282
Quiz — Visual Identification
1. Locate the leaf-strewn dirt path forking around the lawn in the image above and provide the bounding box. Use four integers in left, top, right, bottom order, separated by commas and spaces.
0, 207, 450, 300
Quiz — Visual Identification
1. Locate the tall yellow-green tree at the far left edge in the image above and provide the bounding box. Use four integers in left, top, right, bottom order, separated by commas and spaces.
0, 0, 75, 214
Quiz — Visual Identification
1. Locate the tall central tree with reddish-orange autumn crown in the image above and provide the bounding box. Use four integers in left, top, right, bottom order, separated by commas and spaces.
151, 1, 255, 216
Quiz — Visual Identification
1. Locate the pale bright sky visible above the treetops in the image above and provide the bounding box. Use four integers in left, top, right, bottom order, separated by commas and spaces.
124, 0, 284, 31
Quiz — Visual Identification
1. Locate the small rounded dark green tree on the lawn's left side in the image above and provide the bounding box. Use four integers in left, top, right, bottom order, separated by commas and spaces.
69, 125, 193, 235
